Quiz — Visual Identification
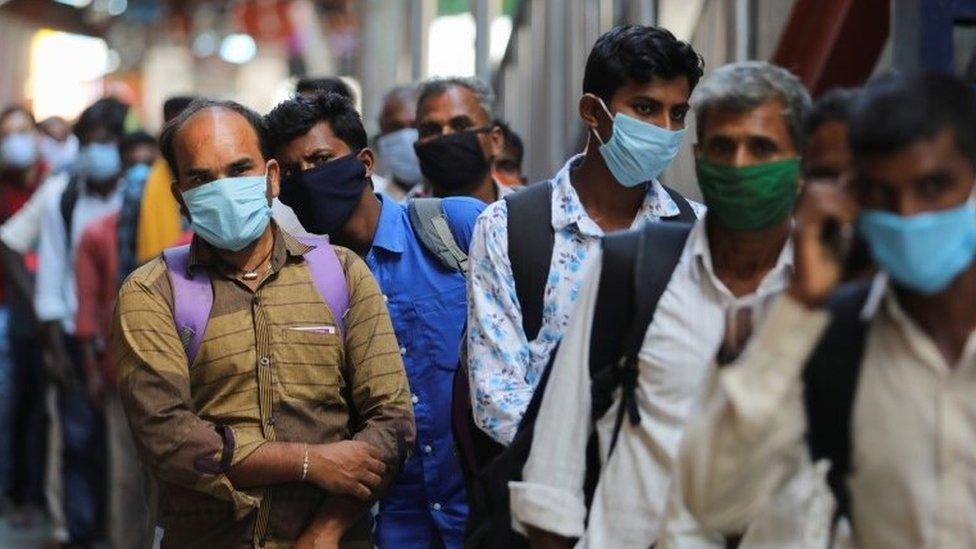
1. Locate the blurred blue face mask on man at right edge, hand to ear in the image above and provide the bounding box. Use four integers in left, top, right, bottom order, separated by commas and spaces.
858, 199, 976, 295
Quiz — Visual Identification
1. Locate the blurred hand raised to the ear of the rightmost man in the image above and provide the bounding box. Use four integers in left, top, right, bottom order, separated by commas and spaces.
789, 181, 858, 307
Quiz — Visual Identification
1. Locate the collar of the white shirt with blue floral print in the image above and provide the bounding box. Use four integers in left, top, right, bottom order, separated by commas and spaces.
550, 153, 681, 236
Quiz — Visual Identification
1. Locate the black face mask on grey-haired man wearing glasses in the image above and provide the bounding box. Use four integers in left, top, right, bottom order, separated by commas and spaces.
413, 128, 490, 194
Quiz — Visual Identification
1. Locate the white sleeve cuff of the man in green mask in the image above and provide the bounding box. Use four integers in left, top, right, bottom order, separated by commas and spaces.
508, 482, 586, 538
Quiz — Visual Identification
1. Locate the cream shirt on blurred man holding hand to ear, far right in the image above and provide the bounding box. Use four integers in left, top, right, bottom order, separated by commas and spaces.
681, 277, 976, 549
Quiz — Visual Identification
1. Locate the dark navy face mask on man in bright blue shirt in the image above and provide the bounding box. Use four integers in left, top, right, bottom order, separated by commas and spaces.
278, 154, 366, 235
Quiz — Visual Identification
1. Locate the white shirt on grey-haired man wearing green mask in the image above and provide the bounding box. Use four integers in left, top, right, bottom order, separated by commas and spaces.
509, 220, 793, 548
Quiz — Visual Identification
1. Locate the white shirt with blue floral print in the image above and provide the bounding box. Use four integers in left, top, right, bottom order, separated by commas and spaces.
468, 155, 704, 445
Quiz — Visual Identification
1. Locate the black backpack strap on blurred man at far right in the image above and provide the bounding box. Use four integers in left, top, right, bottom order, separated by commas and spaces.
803, 282, 871, 519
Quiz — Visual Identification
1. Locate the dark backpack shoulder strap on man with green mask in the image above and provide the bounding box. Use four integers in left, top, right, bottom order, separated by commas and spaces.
590, 223, 692, 449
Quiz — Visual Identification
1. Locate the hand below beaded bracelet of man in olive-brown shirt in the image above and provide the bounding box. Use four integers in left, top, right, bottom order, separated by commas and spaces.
308, 440, 386, 501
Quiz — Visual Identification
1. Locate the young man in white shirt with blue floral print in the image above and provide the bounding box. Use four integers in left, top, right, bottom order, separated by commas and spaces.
468, 25, 703, 445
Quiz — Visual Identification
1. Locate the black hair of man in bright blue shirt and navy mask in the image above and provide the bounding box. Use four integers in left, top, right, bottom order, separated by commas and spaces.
264, 92, 367, 154
